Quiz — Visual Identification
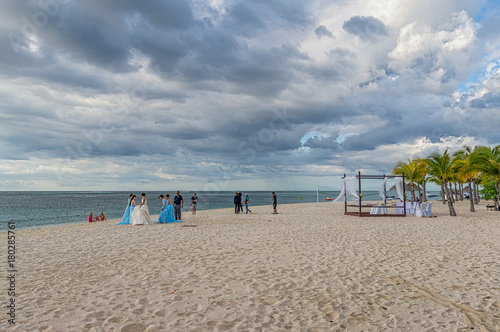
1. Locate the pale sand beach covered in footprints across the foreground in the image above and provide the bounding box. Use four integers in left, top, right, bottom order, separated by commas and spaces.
4, 202, 500, 332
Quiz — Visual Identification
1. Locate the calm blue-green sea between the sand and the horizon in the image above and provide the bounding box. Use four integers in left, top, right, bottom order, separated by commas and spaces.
0, 191, 438, 232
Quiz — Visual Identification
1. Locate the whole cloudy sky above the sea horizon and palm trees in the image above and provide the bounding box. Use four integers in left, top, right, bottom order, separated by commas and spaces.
0, 0, 500, 191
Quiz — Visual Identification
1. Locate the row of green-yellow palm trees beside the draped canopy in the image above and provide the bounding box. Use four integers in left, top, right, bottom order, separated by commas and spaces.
392, 145, 500, 216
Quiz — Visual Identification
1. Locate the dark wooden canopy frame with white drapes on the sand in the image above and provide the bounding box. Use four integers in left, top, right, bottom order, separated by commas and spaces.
343, 172, 406, 217
